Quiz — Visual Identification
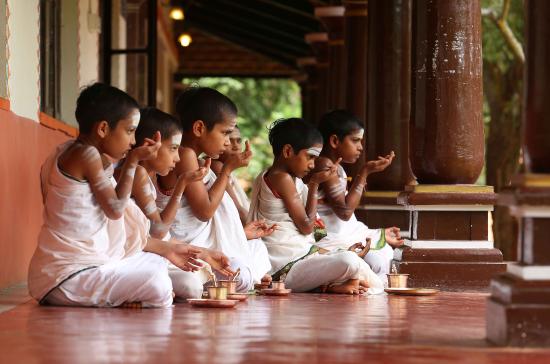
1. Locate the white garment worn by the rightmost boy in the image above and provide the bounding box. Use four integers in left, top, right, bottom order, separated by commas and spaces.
315, 166, 393, 285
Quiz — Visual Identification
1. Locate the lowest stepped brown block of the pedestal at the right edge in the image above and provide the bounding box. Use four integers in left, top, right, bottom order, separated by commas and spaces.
487, 273, 550, 347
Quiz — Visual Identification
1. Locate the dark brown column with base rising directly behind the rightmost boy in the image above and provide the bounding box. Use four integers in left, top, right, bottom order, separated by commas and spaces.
357, 0, 415, 237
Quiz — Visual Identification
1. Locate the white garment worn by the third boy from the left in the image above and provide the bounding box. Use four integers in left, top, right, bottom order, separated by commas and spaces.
157, 171, 271, 292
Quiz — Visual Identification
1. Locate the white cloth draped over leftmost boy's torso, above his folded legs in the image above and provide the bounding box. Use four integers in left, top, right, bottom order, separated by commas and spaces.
28, 140, 126, 300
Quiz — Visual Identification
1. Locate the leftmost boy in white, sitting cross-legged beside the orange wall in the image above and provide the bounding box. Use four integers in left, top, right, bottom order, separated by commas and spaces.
28, 83, 226, 307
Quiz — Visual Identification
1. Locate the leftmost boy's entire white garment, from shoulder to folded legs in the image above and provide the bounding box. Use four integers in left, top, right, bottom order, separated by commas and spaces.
28, 141, 172, 306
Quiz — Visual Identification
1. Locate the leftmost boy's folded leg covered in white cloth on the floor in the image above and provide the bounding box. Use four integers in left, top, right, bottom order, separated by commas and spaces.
46, 252, 173, 307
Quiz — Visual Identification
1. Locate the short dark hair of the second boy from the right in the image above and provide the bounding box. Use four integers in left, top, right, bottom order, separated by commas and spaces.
269, 118, 323, 158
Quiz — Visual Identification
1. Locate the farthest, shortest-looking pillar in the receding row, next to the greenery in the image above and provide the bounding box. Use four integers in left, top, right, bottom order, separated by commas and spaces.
296, 57, 319, 124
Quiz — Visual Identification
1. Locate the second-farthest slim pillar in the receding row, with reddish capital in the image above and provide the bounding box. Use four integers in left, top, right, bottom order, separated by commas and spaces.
305, 33, 329, 124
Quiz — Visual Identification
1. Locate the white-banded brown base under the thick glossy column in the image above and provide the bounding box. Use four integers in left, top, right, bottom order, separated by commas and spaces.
394, 185, 506, 290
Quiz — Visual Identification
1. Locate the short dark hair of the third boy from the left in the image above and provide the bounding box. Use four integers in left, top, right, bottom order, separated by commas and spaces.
176, 86, 237, 131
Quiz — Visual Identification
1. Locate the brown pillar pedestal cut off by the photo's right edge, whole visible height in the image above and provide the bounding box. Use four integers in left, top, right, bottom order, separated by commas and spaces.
487, 174, 550, 347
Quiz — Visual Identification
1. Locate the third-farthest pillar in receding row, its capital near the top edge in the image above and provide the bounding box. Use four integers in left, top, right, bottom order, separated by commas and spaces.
315, 6, 347, 110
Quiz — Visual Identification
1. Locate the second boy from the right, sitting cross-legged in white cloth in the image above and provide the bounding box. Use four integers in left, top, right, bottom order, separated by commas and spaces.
248, 118, 383, 294
